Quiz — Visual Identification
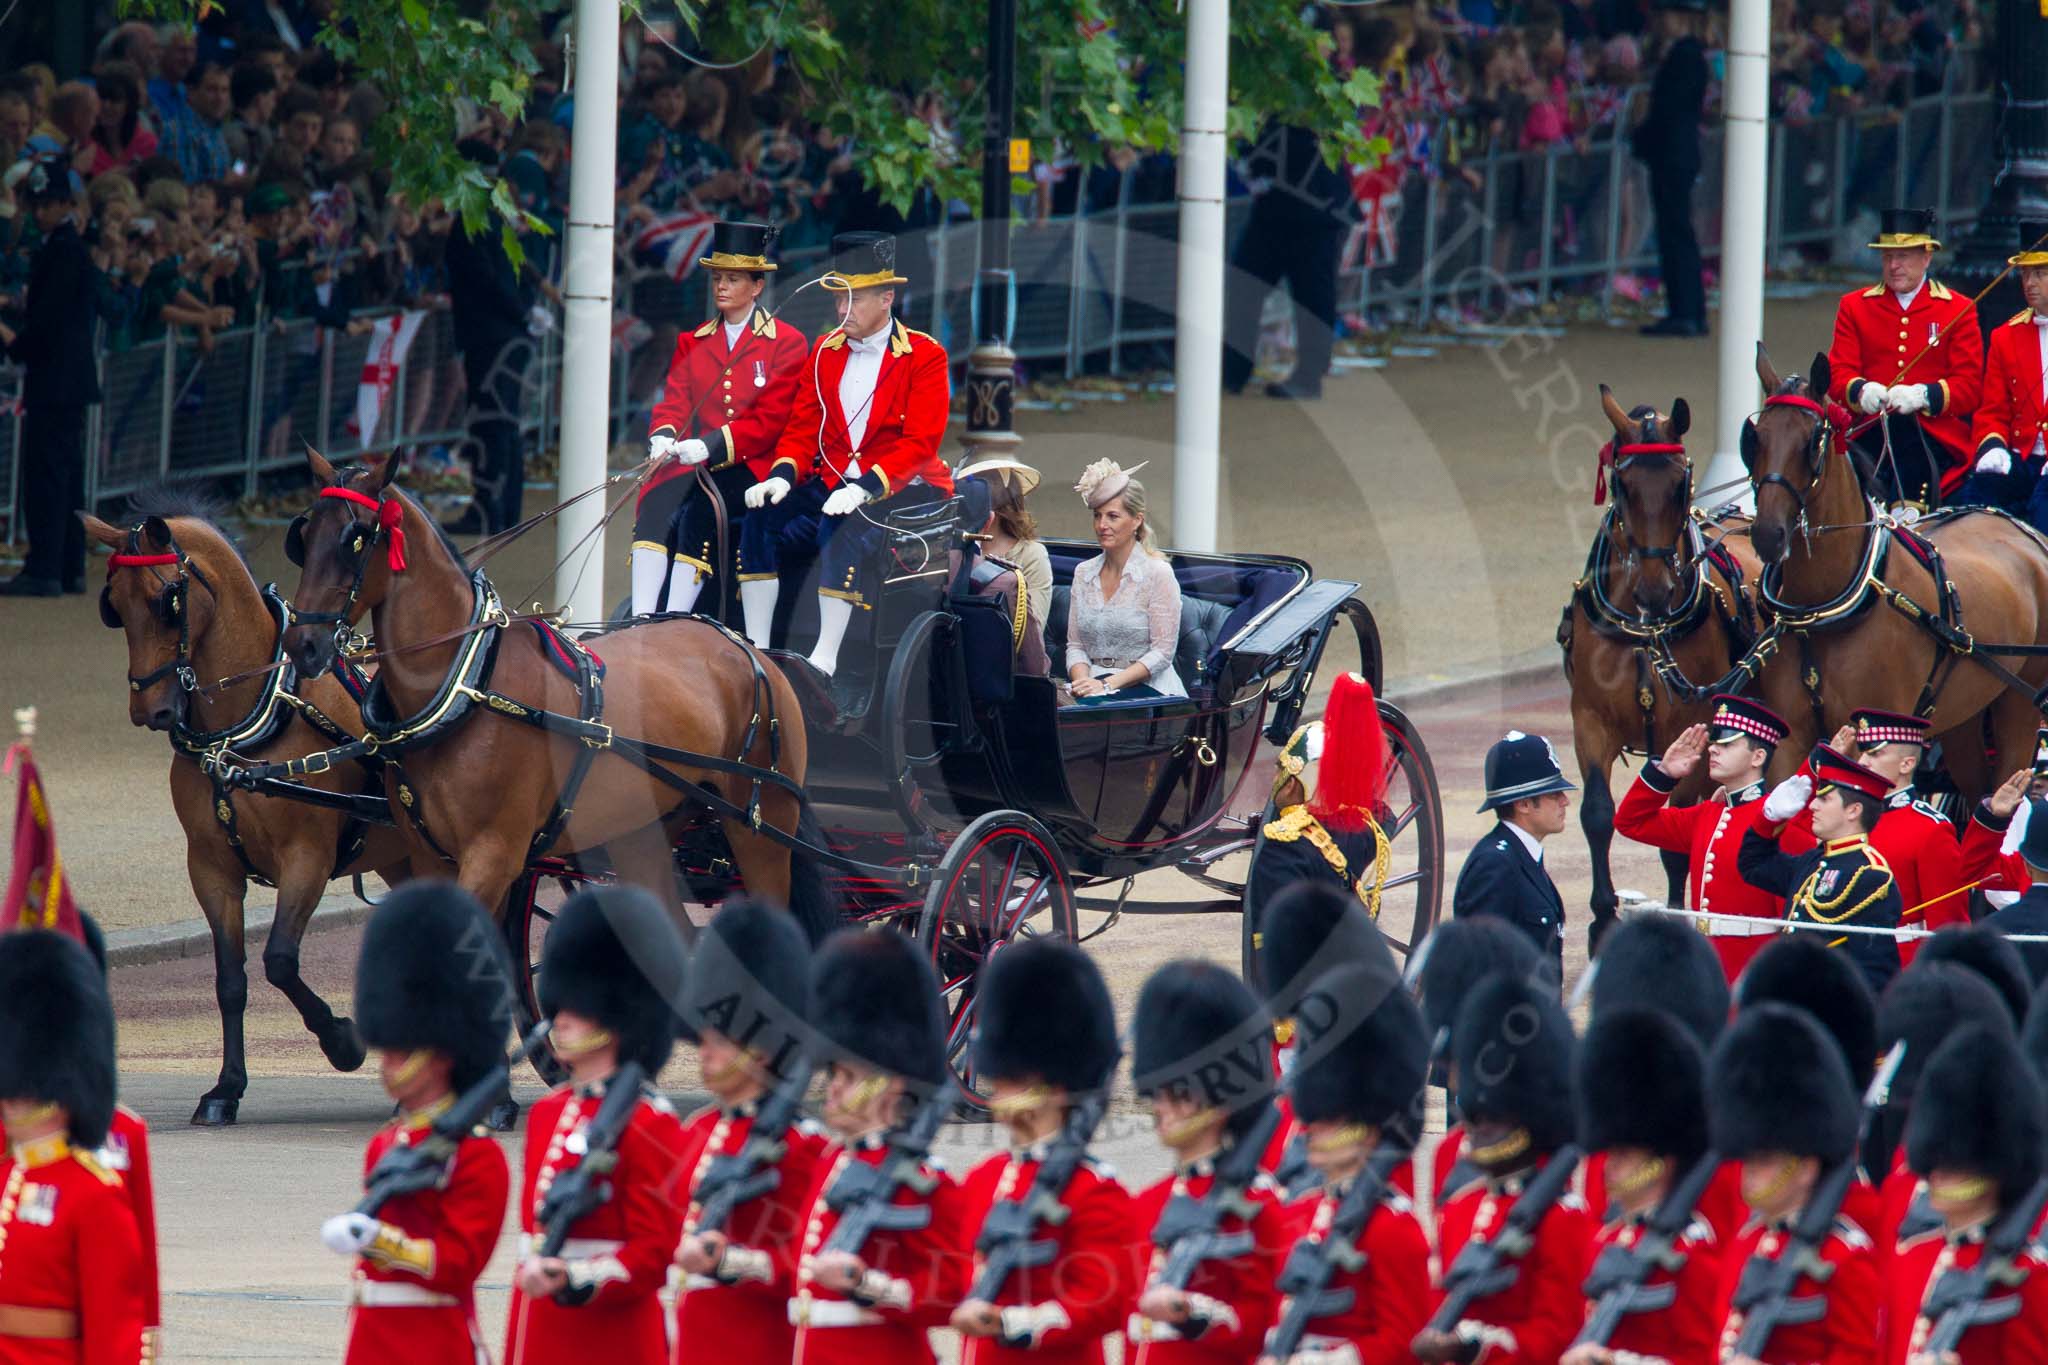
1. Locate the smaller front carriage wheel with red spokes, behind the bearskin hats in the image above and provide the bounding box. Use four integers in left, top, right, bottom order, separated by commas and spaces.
918, 810, 1077, 1111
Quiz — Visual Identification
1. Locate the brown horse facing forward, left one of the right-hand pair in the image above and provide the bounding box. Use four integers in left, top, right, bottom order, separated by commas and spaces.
1559, 385, 1796, 917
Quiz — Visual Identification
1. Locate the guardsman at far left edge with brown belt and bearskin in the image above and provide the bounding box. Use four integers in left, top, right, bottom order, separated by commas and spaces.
0, 929, 150, 1365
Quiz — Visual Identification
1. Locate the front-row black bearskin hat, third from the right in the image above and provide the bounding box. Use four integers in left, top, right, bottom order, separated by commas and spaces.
1573, 1002, 1706, 1166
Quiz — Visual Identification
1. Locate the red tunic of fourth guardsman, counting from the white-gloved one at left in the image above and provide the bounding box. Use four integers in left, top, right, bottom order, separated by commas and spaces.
786, 1134, 973, 1365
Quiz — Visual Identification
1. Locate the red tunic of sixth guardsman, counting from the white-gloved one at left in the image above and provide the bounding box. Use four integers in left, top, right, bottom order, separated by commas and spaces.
1124, 1160, 1294, 1365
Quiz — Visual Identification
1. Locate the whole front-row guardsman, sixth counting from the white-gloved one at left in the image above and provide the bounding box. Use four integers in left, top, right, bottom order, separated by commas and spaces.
1124, 958, 1290, 1365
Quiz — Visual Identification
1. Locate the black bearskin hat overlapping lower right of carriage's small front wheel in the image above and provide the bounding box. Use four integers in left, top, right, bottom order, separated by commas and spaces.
973, 937, 1122, 1095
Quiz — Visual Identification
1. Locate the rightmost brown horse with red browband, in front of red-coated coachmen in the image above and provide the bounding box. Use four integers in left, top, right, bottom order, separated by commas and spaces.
1743, 344, 2048, 800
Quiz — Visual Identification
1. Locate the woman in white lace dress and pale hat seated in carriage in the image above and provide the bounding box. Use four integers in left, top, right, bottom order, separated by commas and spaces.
1067, 460, 1188, 698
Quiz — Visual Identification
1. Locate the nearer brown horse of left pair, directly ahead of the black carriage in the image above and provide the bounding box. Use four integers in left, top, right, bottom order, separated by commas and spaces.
287, 450, 829, 935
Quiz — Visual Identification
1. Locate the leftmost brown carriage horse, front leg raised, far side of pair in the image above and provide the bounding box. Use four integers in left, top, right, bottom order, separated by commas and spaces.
82, 495, 410, 1126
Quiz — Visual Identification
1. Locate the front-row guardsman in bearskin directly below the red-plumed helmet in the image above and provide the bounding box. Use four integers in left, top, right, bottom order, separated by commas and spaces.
1264, 962, 1432, 1365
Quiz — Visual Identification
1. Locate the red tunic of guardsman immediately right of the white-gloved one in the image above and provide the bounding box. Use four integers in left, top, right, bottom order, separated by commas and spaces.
506, 1085, 686, 1365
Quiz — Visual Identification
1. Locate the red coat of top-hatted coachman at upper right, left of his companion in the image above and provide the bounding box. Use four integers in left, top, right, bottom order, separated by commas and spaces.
1827, 280, 1985, 493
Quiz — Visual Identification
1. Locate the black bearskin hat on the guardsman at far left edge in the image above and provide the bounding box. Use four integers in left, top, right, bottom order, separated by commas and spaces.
0, 929, 115, 1148
